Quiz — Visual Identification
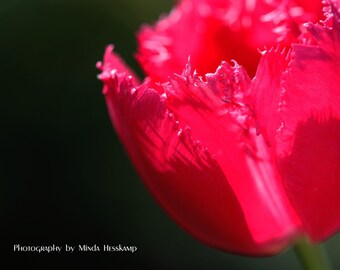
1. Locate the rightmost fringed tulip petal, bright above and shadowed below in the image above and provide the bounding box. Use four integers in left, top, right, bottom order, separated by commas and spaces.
277, 2, 340, 240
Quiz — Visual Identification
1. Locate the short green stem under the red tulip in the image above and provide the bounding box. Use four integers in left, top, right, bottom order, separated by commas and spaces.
294, 237, 332, 270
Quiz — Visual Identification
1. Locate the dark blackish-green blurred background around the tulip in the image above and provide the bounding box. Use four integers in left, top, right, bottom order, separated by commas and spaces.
0, 0, 340, 270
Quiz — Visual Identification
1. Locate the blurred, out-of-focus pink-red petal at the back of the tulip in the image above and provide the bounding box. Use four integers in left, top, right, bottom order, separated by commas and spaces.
137, 0, 278, 82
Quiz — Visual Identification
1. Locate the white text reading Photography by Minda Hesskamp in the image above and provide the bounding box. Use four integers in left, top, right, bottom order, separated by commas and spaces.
13, 244, 138, 253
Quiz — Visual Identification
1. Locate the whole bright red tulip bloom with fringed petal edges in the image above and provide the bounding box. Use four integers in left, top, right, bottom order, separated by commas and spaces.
98, 0, 340, 256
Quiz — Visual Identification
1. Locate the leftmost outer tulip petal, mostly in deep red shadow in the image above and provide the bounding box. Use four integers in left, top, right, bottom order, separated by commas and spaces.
100, 47, 295, 255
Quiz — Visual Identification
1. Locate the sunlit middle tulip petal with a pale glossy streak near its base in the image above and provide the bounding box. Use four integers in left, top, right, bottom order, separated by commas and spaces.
166, 63, 299, 251
